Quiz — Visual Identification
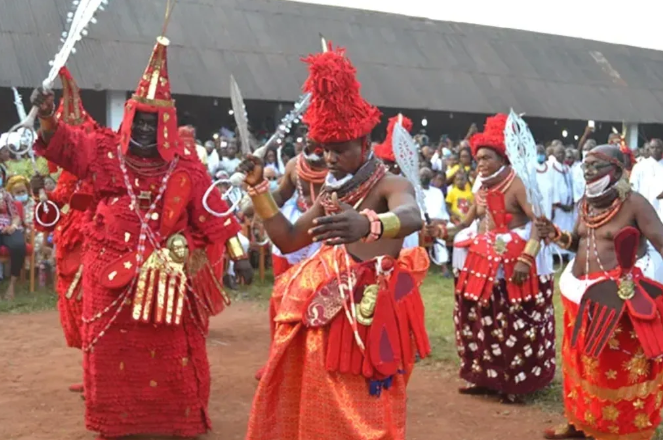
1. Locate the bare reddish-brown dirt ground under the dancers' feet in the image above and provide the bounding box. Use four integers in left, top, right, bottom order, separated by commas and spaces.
0, 303, 561, 440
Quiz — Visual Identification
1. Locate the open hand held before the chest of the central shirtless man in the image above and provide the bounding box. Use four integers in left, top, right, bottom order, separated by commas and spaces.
308, 193, 371, 246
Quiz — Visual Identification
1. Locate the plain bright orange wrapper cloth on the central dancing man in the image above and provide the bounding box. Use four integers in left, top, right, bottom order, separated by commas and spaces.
246, 247, 430, 440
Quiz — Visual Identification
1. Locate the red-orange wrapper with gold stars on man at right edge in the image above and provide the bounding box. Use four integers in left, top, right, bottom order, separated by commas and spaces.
562, 297, 663, 440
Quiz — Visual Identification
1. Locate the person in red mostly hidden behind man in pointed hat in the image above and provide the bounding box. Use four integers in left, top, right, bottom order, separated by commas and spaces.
35, 67, 99, 392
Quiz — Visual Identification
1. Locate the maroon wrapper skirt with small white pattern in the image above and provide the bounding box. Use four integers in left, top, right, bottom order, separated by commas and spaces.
454, 276, 555, 394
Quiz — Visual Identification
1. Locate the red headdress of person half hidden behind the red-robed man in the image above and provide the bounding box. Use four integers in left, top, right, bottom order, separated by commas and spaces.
48, 67, 99, 173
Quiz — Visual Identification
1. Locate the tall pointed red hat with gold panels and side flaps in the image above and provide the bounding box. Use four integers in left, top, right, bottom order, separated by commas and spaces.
120, 37, 181, 162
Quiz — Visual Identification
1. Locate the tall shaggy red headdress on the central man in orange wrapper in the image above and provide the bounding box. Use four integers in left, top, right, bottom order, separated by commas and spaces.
303, 43, 381, 144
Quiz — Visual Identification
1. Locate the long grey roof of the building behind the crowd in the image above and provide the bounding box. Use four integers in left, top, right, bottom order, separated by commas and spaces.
0, 0, 663, 122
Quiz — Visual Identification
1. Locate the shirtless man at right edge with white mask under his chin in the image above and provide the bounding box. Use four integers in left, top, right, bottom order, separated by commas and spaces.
537, 145, 663, 440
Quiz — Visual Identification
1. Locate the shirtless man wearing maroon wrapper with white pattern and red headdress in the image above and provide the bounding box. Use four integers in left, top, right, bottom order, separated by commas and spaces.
454, 114, 555, 403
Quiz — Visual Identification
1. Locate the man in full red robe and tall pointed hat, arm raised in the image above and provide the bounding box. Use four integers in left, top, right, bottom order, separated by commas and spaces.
32, 37, 250, 439
